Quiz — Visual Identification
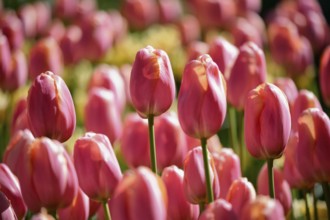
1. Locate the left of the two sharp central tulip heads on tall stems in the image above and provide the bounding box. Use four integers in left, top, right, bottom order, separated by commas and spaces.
130, 46, 175, 118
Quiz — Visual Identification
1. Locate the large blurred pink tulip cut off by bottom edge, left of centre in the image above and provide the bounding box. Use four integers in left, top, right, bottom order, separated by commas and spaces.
110, 167, 167, 220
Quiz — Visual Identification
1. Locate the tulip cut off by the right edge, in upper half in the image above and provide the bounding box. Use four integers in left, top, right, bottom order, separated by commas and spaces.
319, 46, 330, 107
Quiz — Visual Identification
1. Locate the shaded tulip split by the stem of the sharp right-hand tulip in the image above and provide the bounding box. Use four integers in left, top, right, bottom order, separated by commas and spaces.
257, 164, 292, 215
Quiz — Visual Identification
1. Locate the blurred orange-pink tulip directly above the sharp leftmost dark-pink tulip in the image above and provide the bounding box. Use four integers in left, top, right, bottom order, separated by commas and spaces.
29, 37, 63, 79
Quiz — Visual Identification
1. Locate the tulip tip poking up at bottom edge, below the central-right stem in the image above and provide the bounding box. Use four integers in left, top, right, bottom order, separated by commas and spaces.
198, 199, 238, 220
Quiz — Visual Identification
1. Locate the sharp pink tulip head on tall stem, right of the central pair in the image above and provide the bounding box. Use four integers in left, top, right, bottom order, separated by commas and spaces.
244, 83, 291, 159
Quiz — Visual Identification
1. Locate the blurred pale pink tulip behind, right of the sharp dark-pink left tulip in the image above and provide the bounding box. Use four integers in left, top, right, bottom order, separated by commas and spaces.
84, 88, 122, 144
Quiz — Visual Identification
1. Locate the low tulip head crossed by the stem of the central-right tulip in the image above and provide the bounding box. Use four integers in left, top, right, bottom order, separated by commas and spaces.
183, 147, 220, 204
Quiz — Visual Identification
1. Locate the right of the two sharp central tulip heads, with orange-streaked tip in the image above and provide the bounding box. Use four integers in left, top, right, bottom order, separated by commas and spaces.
178, 55, 227, 138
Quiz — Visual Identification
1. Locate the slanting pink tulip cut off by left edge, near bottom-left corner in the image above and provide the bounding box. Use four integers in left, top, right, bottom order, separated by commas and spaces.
0, 163, 27, 219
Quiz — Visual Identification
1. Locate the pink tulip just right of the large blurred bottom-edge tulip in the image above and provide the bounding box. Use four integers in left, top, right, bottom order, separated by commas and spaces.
161, 165, 199, 220
